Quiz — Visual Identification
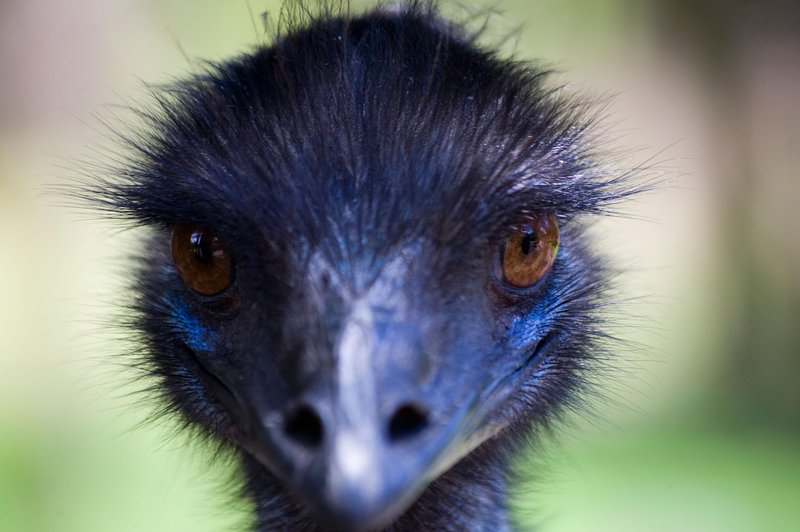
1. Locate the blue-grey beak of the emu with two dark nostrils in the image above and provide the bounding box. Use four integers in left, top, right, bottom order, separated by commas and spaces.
261, 306, 474, 531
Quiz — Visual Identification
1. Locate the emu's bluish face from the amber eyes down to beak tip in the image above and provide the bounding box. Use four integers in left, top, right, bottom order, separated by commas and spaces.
145, 199, 576, 528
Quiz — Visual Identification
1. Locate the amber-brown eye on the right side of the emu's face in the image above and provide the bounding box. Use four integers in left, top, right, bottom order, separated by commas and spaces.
500, 214, 558, 288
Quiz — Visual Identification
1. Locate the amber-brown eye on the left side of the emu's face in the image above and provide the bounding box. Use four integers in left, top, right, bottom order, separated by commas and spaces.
172, 224, 233, 296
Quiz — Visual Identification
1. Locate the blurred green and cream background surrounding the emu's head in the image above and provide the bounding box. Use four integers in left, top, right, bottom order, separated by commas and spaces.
0, 0, 800, 532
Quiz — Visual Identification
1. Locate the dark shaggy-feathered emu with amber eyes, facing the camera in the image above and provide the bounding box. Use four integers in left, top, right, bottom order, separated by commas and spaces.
76, 1, 635, 531
